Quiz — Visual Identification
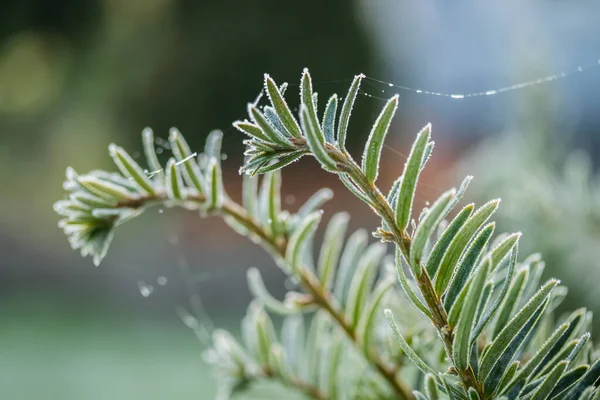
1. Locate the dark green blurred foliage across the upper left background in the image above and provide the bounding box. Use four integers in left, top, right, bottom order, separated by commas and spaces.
0, 0, 372, 149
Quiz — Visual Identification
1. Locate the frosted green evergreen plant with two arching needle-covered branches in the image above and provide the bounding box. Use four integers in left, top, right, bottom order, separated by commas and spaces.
55, 70, 600, 400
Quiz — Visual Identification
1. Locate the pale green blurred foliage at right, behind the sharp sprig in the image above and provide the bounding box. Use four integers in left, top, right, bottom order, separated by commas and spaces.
458, 87, 600, 329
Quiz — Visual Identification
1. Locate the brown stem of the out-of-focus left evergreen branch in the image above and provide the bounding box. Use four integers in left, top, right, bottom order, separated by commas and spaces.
117, 192, 414, 400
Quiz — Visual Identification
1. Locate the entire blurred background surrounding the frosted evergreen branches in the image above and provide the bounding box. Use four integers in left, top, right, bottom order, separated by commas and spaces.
0, 0, 600, 400
